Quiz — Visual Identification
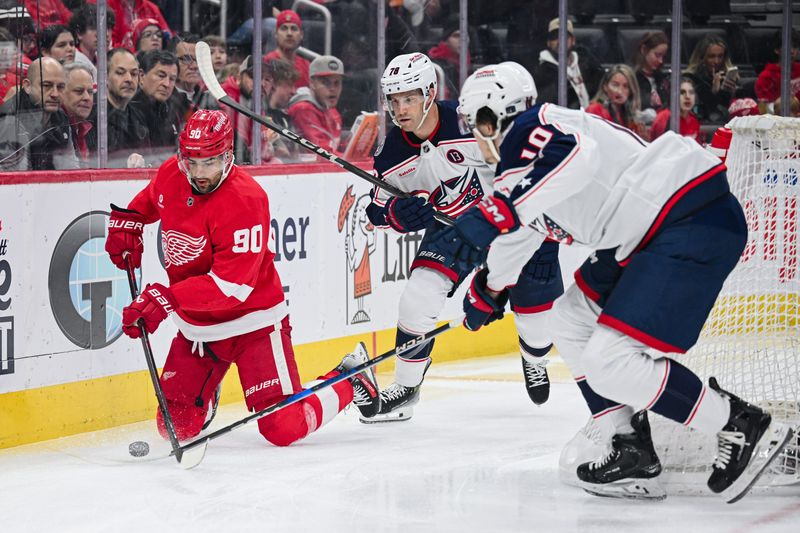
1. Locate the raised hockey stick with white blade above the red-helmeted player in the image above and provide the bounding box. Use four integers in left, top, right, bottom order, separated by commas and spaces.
195, 41, 453, 226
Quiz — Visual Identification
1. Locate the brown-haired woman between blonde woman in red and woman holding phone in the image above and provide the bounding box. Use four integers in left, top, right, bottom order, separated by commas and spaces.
633, 31, 669, 112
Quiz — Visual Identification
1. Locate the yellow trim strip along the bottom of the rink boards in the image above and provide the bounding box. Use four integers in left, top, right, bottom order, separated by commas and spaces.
0, 316, 517, 449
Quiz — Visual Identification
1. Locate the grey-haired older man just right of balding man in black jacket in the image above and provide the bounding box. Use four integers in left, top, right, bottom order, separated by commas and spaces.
61, 62, 97, 163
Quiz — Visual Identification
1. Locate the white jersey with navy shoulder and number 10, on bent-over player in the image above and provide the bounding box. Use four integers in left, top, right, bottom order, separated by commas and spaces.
494, 104, 727, 261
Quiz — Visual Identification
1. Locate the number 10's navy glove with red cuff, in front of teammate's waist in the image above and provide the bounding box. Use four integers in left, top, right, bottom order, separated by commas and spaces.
430, 195, 519, 272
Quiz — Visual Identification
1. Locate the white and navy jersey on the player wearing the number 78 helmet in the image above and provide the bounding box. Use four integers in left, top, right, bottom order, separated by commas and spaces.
373, 101, 494, 222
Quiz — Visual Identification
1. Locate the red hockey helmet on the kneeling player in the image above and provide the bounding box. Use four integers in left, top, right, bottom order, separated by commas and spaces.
178, 109, 233, 189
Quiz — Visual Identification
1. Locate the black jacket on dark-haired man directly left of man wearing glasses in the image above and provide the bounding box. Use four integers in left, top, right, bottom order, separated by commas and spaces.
128, 89, 183, 167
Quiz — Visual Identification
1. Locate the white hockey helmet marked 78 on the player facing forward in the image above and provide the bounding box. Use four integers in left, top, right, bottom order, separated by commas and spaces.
381, 53, 439, 127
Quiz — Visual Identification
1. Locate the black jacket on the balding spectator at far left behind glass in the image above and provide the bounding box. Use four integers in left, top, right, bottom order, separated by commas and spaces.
0, 90, 79, 170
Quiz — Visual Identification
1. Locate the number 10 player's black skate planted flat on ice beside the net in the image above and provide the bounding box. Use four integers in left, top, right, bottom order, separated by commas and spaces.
577, 411, 667, 500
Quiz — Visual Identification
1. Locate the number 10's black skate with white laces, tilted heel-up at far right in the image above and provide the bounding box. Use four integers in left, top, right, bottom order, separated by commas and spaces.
708, 377, 793, 503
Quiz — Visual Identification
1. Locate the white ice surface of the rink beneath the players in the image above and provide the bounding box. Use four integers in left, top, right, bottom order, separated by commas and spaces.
0, 354, 800, 533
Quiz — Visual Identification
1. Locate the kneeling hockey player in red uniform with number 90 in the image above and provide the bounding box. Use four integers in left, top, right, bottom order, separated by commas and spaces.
106, 110, 380, 446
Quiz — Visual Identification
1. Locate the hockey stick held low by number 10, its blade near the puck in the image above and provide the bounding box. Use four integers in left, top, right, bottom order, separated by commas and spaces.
170, 317, 463, 455
